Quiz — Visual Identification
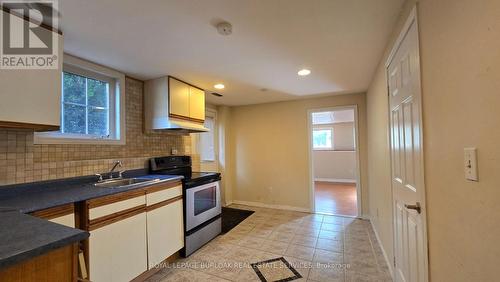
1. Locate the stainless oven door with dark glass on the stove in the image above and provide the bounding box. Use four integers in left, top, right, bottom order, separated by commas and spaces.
186, 181, 221, 231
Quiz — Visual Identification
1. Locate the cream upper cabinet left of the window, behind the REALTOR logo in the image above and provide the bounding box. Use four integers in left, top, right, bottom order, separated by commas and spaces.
0, 11, 63, 131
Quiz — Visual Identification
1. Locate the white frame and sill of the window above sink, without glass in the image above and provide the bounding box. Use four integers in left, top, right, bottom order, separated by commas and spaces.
34, 54, 126, 145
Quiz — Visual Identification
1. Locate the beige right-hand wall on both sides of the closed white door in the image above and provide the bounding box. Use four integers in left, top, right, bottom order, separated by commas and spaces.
367, 0, 500, 281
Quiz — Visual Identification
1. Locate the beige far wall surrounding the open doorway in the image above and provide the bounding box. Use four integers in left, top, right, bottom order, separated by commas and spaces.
229, 94, 368, 215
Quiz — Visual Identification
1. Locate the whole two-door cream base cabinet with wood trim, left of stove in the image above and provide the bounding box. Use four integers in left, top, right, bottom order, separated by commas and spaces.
84, 182, 184, 282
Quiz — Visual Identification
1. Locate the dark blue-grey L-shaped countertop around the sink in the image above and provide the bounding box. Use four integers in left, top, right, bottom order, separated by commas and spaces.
0, 171, 182, 268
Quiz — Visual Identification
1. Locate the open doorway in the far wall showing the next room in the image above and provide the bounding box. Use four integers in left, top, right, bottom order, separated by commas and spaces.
308, 106, 361, 217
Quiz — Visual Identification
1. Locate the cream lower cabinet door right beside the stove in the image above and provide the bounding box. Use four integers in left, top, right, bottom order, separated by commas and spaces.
147, 199, 184, 269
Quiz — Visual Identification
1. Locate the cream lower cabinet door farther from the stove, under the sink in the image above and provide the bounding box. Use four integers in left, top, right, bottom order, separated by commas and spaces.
89, 212, 147, 282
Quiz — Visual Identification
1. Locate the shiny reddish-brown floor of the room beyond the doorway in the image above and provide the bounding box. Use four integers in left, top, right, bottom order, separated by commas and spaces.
314, 181, 358, 216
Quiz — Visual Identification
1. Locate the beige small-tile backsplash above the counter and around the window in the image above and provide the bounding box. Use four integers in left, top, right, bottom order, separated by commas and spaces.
0, 78, 197, 185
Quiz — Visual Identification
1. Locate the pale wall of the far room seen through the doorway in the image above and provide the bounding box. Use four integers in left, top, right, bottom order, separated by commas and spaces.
313, 122, 356, 182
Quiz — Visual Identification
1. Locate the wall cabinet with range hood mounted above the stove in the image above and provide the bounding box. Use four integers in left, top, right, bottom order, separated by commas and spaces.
144, 76, 210, 133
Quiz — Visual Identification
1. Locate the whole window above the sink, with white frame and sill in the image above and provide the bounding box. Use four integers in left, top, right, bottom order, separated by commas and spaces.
35, 55, 125, 144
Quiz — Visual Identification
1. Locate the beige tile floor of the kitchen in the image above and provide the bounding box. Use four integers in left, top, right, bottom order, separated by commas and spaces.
147, 205, 392, 282
